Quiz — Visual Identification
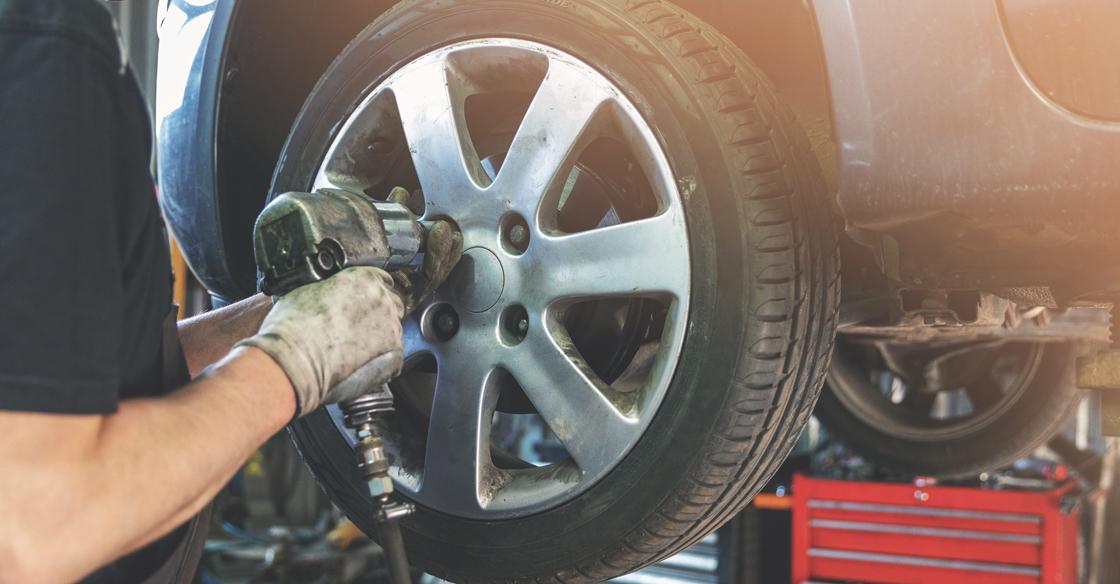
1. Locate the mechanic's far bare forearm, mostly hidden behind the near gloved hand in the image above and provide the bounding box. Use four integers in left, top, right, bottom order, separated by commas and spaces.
179, 294, 272, 377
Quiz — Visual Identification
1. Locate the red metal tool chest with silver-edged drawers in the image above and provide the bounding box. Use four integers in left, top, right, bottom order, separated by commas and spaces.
792, 475, 1080, 584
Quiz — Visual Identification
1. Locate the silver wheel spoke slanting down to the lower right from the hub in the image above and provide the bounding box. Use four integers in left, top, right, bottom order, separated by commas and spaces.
503, 324, 641, 475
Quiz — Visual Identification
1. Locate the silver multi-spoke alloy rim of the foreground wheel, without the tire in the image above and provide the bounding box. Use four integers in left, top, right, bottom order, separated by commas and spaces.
314, 38, 691, 519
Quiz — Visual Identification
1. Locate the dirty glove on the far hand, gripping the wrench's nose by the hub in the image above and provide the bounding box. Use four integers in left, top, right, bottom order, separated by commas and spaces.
389, 187, 463, 318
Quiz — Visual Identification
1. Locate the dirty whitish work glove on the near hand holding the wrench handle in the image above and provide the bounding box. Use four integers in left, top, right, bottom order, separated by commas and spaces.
234, 267, 404, 417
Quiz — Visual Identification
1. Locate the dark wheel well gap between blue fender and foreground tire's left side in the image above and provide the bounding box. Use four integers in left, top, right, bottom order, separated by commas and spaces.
214, 0, 394, 296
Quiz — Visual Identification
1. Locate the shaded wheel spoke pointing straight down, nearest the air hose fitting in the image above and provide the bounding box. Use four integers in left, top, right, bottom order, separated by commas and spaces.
420, 349, 497, 510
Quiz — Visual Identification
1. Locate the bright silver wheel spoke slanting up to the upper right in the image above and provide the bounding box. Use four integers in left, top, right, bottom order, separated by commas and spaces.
493, 58, 610, 217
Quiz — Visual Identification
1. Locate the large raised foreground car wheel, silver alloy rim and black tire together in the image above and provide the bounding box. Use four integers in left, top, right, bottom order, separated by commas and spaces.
272, 0, 839, 584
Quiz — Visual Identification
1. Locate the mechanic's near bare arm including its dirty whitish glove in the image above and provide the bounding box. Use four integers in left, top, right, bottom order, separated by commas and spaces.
0, 268, 403, 584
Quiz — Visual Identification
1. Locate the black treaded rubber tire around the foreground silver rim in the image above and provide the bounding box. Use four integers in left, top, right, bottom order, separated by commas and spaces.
272, 0, 839, 584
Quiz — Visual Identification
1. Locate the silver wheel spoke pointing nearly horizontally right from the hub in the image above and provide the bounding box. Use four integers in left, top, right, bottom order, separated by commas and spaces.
526, 210, 690, 302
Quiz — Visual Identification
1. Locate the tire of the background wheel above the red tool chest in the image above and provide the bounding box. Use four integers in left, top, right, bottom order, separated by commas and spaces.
814, 343, 1082, 479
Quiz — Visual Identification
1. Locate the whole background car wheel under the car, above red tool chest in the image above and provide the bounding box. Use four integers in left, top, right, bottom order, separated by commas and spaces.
815, 334, 1082, 478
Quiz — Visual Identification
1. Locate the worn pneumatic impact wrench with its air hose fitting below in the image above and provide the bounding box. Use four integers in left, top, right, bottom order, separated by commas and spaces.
253, 189, 428, 584
